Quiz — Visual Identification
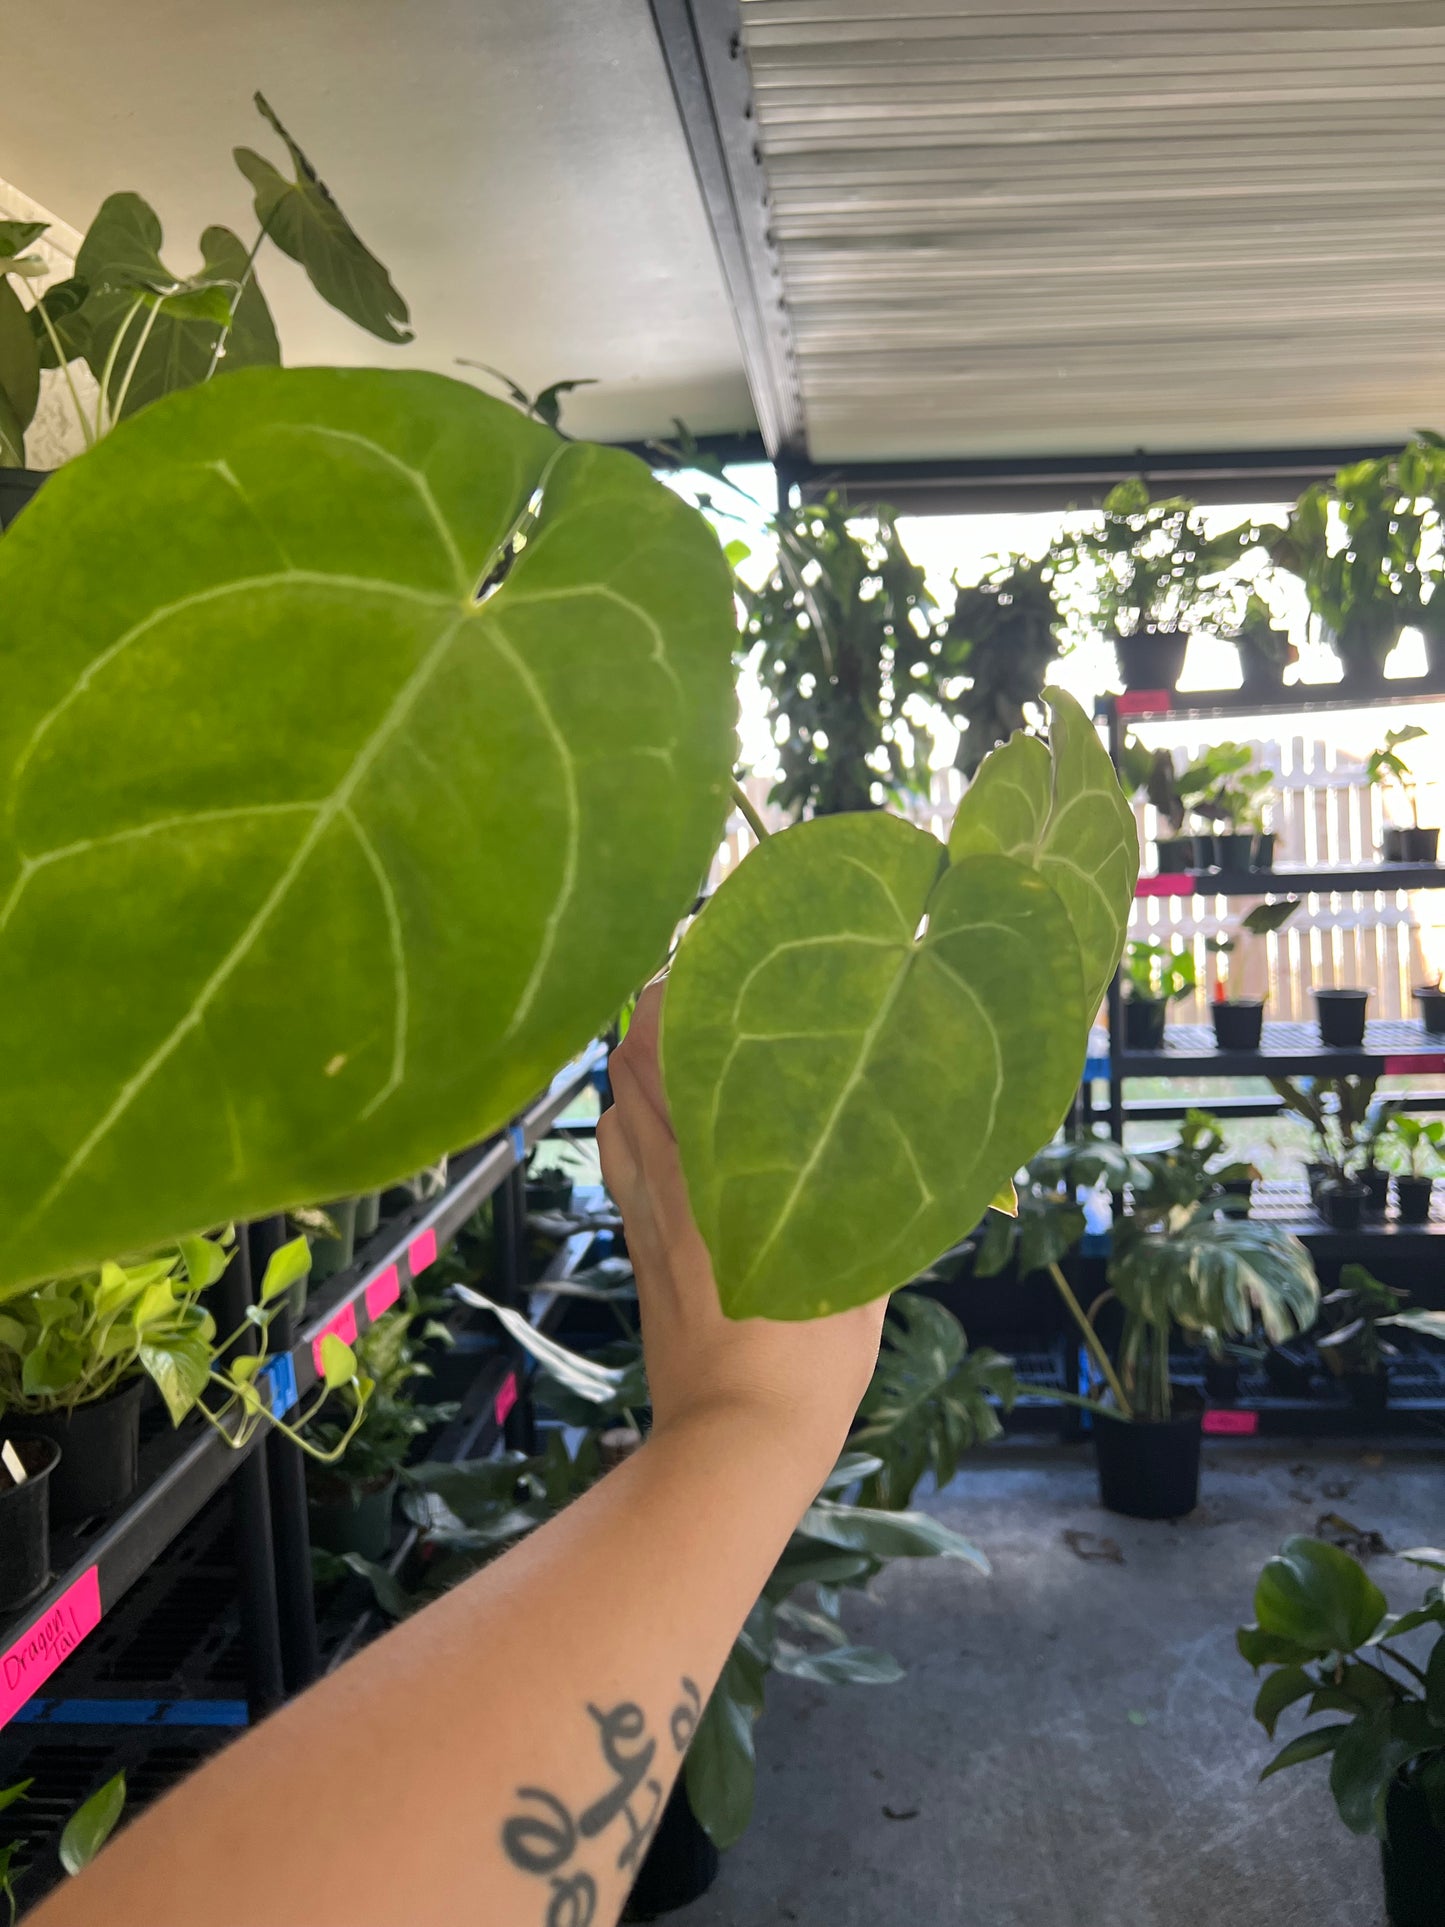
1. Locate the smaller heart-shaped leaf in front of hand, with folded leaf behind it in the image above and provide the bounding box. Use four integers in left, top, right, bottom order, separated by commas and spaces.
663, 692, 1139, 1318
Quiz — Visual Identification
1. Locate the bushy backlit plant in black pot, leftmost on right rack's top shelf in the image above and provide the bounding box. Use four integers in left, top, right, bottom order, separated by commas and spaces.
1052, 480, 1220, 690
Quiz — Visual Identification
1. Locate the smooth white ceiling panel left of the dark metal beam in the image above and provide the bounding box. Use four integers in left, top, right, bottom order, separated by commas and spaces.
0, 0, 753, 439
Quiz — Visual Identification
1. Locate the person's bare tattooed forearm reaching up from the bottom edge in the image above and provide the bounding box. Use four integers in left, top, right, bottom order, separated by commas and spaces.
35, 1409, 836, 1927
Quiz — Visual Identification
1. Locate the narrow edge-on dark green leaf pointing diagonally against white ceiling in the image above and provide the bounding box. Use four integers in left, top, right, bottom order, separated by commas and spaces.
235, 94, 412, 341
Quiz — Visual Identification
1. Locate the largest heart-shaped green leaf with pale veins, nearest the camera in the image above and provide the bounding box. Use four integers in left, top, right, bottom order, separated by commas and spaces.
0, 370, 734, 1287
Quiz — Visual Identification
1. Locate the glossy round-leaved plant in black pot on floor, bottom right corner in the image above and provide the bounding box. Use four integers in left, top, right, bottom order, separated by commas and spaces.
1235, 1538, 1445, 1927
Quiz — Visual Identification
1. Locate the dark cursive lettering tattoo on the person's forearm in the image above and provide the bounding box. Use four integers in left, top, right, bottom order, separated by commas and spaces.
501, 1678, 701, 1927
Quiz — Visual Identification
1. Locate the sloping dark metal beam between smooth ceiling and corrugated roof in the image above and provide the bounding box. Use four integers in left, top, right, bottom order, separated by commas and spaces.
651, 0, 803, 455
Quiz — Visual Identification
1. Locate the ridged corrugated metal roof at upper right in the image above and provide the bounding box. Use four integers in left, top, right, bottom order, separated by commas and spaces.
742, 0, 1445, 461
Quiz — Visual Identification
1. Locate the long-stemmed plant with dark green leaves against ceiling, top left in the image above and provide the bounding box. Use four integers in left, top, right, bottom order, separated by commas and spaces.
0, 94, 410, 468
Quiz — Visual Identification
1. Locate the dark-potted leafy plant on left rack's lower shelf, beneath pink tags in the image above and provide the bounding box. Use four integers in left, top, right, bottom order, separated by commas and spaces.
306, 1307, 460, 1559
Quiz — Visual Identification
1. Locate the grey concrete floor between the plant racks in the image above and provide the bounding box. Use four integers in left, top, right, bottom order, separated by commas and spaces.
674, 1441, 1445, 1927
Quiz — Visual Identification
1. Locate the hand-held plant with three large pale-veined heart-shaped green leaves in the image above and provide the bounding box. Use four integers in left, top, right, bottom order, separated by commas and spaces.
0, 370, 1137, 1318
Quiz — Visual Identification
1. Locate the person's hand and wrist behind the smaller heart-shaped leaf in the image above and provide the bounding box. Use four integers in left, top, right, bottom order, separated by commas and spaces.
597, 979, 886, 1480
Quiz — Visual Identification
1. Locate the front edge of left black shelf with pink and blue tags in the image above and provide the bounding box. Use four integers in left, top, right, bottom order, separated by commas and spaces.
0, 1044, 607, 1727
